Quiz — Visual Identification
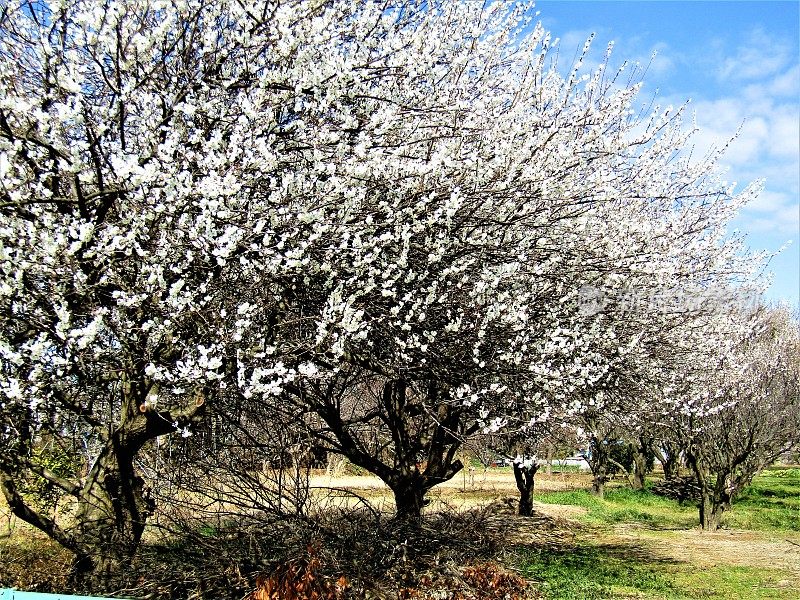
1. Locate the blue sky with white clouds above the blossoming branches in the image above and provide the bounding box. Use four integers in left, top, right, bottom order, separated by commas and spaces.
536, 0, 800, 307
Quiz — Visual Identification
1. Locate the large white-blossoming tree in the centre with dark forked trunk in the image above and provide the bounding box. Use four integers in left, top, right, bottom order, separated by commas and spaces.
228, 8, 760, 516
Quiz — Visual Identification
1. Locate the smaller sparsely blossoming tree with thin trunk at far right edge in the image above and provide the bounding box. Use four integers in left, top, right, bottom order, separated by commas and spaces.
673, 308, 800, 531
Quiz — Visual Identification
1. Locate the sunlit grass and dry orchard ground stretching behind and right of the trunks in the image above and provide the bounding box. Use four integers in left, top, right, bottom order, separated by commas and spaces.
312, 468, 800, 599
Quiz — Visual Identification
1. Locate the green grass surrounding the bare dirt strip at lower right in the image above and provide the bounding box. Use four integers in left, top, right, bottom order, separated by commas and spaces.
518, 469, 800, 600
